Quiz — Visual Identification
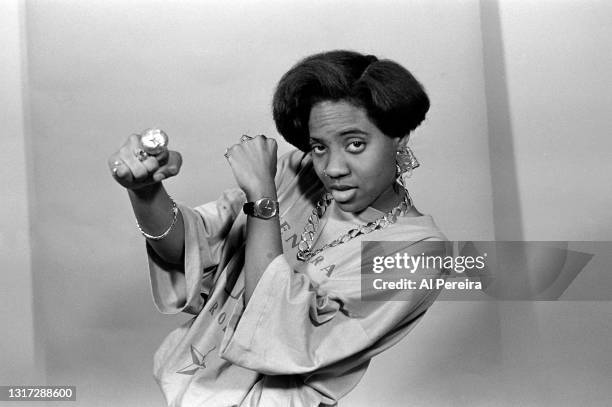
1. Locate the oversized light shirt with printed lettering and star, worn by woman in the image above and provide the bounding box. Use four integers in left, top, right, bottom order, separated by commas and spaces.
148, 150, 445, 407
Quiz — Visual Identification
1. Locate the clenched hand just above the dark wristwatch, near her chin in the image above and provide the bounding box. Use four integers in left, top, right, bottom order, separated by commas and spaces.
225, 135, 277, 200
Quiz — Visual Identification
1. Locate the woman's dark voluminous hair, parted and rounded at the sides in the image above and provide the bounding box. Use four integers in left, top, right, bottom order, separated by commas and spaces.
272, 50, 429, 151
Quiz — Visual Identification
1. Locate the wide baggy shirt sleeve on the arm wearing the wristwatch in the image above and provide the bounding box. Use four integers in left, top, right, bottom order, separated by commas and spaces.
221, 239, 450, 375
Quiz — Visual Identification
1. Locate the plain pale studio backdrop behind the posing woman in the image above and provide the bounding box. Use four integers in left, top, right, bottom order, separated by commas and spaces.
0, 0, 612, 407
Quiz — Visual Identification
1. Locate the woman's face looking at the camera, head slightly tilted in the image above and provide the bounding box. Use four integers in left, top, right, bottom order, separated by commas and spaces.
308, 101, 401, 212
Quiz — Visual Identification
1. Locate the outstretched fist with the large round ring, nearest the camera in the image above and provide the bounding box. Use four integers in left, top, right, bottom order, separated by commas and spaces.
108, 134, 183, 190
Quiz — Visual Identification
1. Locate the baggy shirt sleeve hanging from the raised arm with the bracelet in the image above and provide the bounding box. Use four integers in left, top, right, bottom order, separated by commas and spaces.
147, 189, 245, 315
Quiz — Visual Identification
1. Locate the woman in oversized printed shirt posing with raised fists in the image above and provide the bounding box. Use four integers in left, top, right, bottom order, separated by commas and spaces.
109, 51, 444, 407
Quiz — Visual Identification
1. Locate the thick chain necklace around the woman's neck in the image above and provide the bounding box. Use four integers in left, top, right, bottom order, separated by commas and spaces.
297, 190, 412, 261
